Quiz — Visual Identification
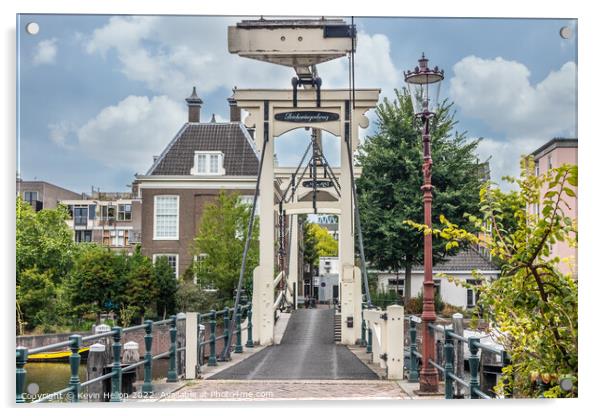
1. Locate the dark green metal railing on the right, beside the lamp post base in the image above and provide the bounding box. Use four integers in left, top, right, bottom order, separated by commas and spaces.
405, 316, 512, 399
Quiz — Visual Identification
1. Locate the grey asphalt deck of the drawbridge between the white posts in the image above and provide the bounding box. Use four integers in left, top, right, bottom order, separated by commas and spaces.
210, 309, 378, 380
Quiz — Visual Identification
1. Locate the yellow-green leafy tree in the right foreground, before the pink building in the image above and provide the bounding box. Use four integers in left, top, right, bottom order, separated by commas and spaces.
414, 158, 578, 397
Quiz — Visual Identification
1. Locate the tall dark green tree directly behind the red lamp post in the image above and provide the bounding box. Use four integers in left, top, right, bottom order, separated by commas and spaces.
357, 90, 483, 302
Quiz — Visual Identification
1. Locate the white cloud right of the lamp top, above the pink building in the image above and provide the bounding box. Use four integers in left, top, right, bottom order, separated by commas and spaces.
450, 56, 577, 139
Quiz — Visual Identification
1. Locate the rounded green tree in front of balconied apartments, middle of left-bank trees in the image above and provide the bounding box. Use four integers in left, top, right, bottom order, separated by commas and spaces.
69, 244, 119, 324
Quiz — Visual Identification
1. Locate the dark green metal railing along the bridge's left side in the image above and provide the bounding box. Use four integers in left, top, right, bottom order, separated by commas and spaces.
16, 305, 253, 403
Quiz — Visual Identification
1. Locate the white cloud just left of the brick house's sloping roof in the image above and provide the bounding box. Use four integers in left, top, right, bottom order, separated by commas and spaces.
76, 95, 186, 173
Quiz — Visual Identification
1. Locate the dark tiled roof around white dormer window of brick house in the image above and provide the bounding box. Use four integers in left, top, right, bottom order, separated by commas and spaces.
147, 123, 259, 176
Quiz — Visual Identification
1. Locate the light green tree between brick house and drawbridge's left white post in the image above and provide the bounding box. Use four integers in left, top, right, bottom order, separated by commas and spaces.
192, 191, 259, 299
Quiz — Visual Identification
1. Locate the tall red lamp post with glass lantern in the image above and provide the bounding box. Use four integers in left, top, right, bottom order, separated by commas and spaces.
404, 54, 443, 393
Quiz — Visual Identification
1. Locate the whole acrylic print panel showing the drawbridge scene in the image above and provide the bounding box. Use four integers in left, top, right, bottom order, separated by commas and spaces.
16, 14, 578, 405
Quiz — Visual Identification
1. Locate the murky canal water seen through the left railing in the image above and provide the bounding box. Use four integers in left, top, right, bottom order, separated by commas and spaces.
25, 359, 169, 394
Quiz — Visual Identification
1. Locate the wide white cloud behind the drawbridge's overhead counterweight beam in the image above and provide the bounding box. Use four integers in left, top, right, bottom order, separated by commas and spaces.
85, 16, 400, 105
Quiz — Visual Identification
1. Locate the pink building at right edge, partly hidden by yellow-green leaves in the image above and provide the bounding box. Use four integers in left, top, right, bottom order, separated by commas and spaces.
529, 138, 577, 279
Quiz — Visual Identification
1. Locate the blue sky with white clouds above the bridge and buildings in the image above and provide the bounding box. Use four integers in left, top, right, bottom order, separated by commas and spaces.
17, 15, 577, 192
